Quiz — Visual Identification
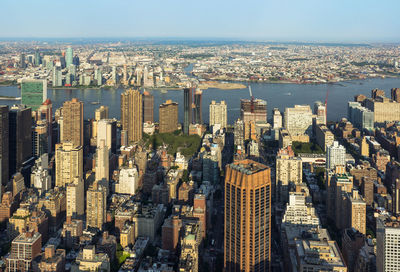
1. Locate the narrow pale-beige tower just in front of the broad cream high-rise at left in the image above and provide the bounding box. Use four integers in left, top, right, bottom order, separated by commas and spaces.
66, 177, 85, 219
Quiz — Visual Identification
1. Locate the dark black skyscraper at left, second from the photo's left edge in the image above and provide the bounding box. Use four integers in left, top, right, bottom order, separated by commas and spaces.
9, 105, 32, 177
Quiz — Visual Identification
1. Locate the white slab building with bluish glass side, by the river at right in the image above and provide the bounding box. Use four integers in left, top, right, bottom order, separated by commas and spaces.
347, 102, 374, 130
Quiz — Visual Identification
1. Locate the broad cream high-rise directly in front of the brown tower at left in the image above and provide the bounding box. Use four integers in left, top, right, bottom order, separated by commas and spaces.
55, 143, 83, 187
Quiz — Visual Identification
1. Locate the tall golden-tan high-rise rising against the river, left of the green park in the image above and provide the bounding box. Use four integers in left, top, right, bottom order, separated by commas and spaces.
121, 90, 143, 143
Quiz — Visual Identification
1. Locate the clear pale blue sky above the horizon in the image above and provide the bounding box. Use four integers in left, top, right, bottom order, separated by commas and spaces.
0, 0, 400, 43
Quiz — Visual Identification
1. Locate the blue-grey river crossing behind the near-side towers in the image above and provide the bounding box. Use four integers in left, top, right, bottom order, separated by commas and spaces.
0, 78, 400, 123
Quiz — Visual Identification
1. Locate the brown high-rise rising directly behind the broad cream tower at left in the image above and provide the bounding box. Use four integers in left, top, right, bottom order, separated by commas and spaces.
61, 98, 84, 147
